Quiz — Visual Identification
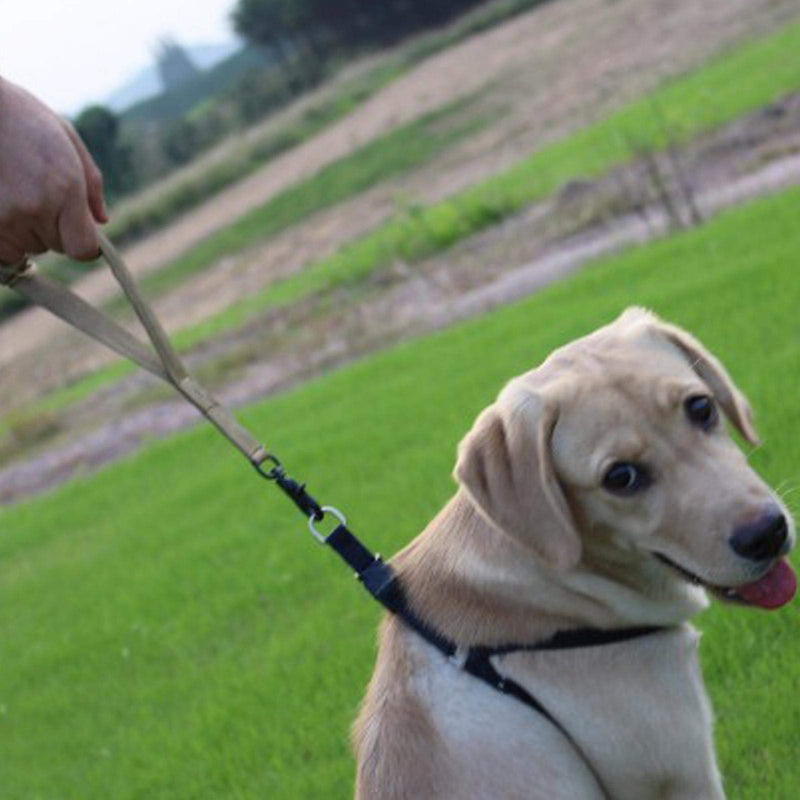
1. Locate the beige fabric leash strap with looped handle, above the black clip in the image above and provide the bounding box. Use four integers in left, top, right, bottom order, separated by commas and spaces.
0, 231, 274, 467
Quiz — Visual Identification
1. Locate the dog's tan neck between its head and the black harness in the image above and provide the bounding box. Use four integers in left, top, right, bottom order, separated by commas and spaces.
392, 491, 707, 646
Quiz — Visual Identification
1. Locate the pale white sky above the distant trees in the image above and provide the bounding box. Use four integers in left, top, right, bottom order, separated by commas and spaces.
0, 0, 241, 114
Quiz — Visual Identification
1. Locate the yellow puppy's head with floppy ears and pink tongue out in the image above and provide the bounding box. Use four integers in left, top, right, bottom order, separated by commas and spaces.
455, 309, 795, 608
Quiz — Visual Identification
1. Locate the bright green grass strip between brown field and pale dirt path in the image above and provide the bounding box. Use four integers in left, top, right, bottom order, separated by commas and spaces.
168, 15, 800, 346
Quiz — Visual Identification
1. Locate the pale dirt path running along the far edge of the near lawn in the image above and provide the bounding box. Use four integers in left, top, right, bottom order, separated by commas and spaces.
0, 138, 800, 504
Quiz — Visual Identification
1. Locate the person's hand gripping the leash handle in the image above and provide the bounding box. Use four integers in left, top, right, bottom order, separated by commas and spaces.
0, 78, 108, 264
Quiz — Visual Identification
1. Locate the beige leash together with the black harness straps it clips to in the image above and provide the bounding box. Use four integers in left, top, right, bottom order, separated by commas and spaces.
0, 239, 663, 798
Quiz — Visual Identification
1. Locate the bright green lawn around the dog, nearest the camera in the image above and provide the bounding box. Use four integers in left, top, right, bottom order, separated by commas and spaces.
0, 183, 800, 800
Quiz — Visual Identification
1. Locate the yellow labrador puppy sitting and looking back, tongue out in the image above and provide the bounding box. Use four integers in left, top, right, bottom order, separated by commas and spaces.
354, 308, 795, 800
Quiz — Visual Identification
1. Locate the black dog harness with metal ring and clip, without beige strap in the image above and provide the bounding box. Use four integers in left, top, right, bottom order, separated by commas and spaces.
266, 463, 666, 799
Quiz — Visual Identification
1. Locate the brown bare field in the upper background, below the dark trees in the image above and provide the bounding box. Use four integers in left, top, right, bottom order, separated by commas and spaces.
0, 0, 800, 376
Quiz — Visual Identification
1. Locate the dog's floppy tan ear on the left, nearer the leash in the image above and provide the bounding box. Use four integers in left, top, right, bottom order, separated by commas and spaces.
455, 387, 581, 570
